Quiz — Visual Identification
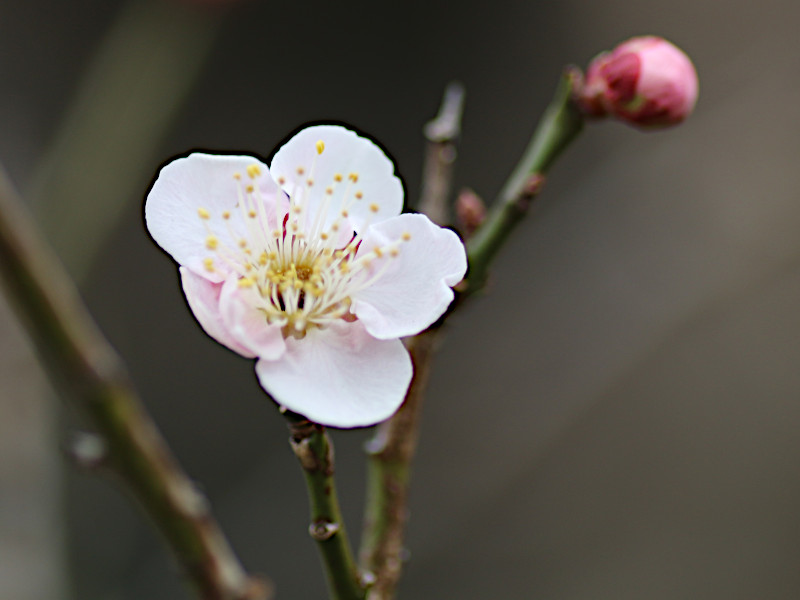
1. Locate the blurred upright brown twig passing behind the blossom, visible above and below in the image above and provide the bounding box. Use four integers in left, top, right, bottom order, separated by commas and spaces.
359, 83, 464, 600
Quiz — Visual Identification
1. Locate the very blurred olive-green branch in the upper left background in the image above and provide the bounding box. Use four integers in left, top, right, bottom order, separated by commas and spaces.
26, 0, 224, 280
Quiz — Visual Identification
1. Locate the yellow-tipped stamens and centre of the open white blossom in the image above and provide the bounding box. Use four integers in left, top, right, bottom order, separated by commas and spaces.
193, 142, 411, 337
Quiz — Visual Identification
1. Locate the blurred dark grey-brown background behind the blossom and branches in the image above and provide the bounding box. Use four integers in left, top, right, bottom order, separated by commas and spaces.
0, 0, 800, 600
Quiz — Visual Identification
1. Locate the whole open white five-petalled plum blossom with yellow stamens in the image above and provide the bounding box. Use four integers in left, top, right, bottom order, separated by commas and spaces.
145, 125, 467, 427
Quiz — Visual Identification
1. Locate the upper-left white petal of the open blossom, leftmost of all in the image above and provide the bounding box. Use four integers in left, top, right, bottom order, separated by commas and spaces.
144, 153, 283, 283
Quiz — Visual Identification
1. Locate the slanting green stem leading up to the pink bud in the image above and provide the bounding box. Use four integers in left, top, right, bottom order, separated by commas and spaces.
464, 69, 584, 295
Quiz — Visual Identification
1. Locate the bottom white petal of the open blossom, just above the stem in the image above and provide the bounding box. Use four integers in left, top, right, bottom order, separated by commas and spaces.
256, 321, 412, 428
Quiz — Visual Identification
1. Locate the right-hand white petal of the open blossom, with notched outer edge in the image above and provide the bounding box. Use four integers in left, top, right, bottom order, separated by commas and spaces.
351, 214, 467, 339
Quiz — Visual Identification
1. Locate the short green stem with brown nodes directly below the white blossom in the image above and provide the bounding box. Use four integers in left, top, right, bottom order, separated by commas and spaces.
286, 412, 366, 600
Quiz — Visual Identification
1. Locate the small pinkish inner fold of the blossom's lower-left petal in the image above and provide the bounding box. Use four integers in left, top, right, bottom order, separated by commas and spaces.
219, 275, 286, 360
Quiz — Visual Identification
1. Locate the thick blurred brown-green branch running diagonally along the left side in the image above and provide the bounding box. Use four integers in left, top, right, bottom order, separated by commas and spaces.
0, 169, 269, 600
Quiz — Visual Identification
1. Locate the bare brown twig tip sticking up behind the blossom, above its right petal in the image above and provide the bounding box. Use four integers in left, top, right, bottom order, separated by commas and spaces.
418, 82, 464, 225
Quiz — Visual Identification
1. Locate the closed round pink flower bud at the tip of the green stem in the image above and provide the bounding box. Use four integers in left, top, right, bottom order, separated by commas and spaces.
578, 36, 698, 127
